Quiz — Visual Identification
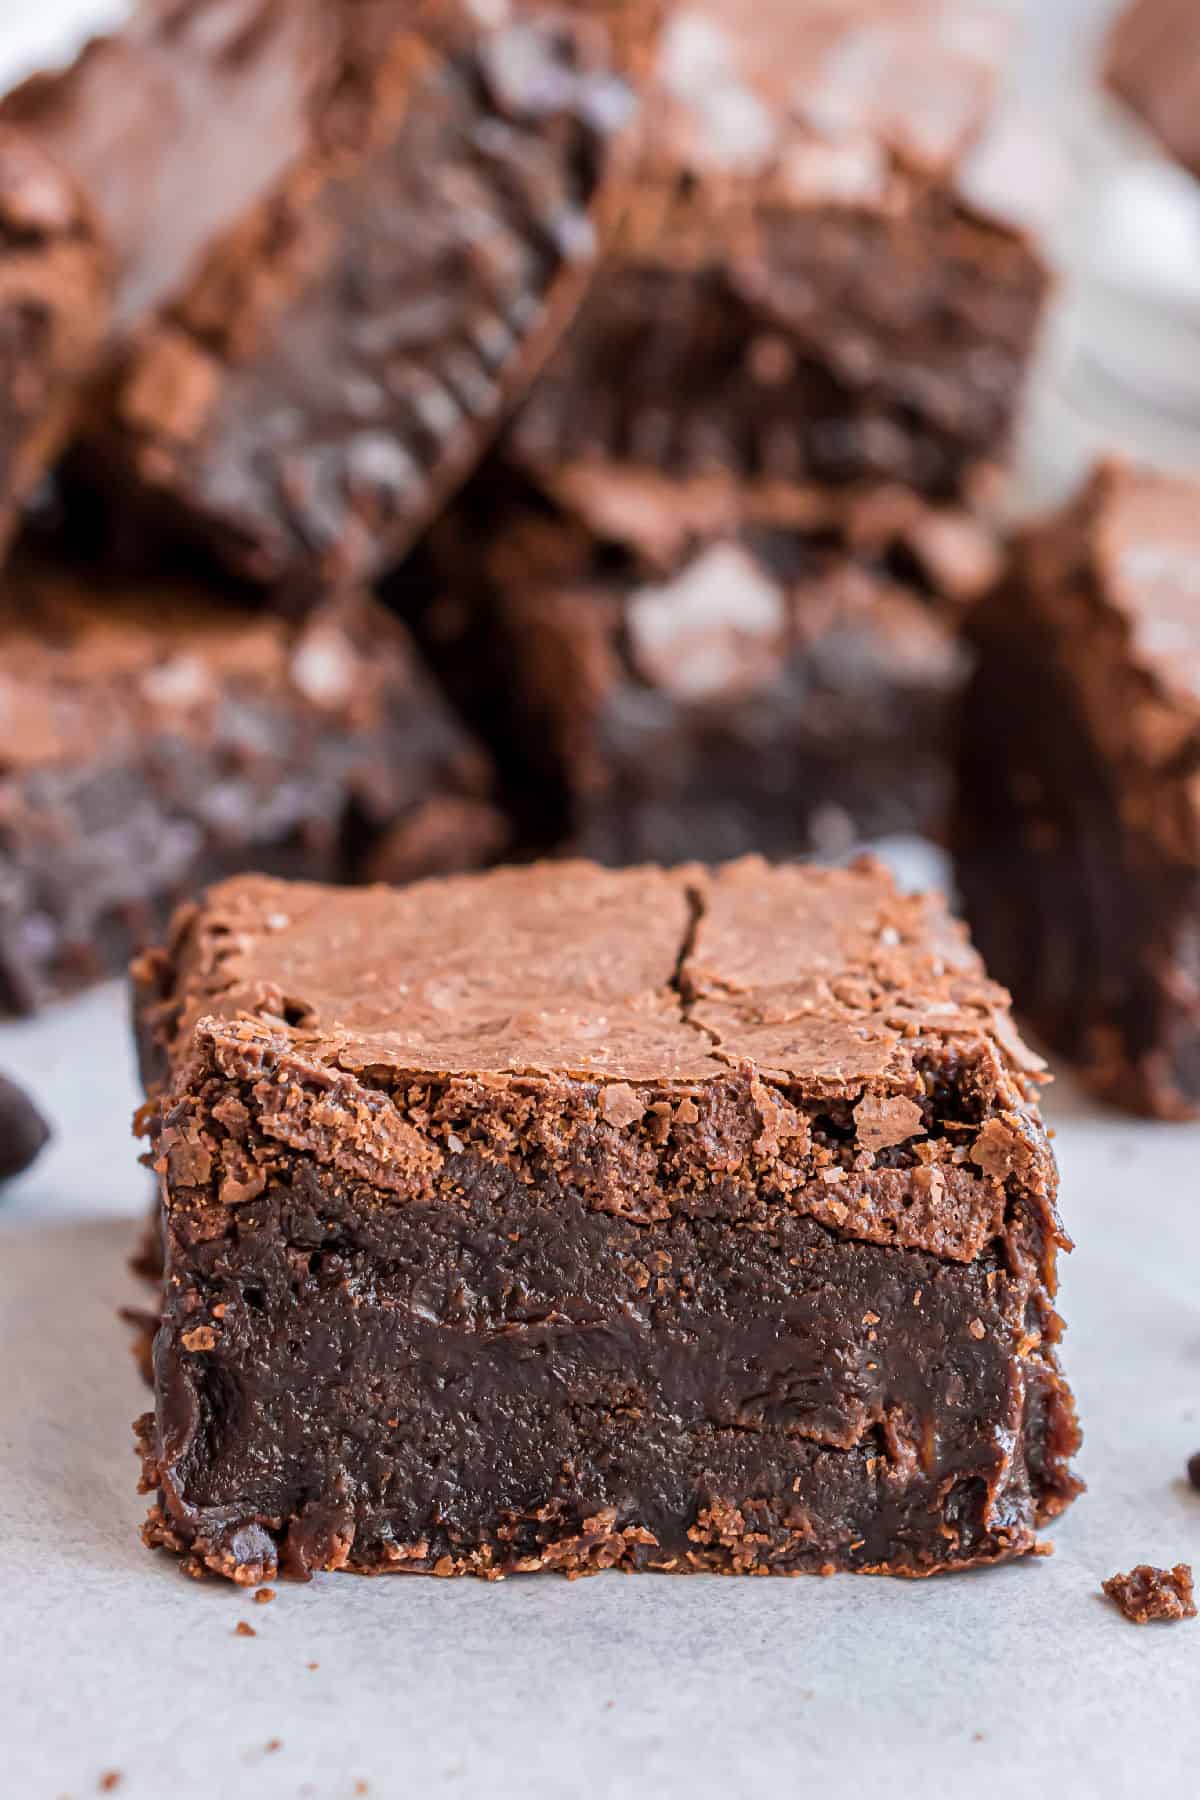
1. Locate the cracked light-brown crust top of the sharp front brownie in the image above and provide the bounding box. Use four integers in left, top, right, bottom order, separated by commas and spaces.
152, 859, 1040, 1103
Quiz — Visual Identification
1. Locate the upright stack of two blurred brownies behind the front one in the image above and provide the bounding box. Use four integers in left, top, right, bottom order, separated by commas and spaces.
417, 0, 1045, 862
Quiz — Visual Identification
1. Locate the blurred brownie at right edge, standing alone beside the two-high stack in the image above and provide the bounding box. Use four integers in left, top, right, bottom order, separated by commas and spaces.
954, 464, 1200, 1118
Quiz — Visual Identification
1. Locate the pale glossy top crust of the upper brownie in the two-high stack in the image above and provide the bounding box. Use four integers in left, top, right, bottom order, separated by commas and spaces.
653, 0, 1007, 188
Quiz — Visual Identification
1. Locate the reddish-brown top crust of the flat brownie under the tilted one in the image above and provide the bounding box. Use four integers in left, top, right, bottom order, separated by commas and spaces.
0, 545, 417, 776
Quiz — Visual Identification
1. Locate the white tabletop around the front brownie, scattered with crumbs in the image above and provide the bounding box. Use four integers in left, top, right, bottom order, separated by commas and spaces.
0, 986, 1200, 1800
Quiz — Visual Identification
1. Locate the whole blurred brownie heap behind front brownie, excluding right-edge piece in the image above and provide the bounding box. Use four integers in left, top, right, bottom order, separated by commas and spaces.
0, 0, 1045, 1010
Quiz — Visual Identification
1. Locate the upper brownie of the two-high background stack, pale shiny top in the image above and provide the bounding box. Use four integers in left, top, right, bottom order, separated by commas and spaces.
511, 0, 1045, 514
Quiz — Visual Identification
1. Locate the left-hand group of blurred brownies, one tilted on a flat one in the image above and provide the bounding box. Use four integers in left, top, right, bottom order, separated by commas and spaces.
0, 0, 640, 1008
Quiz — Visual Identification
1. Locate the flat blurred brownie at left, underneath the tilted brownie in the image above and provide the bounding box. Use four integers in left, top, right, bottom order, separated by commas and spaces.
0, 549, 498, 1012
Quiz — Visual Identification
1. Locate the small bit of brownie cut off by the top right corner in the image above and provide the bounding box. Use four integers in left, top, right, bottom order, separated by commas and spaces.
1105, 0, 1200, 175
